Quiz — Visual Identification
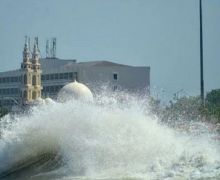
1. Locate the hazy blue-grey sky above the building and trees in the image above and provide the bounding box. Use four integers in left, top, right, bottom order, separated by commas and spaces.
0, 0, 220, 100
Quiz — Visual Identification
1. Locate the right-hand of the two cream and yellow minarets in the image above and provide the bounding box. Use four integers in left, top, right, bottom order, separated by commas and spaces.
32, 37, 42, 100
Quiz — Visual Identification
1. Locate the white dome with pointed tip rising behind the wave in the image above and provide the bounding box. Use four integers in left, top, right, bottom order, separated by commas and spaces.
58, 81, 93, 102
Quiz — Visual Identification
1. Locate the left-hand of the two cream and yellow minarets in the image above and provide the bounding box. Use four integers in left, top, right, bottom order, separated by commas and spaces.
21, 36, 33, 104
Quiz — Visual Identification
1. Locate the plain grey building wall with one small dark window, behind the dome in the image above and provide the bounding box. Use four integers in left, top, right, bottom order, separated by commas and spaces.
79, 66, 150, 93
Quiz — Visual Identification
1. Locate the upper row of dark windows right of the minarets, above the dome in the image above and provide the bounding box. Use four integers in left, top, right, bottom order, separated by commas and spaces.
41, 72, 78, 81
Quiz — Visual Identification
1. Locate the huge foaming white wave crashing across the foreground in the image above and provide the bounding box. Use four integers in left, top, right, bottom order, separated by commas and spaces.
0, 94, 220, 180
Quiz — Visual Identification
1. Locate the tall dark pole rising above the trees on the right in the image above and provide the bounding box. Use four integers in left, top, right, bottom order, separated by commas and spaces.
199, 0, 205, 107
